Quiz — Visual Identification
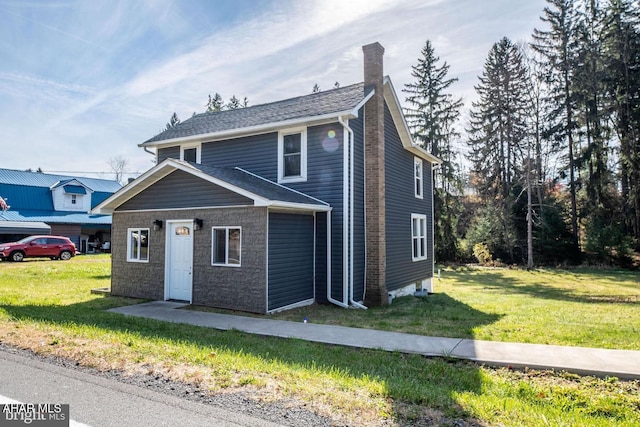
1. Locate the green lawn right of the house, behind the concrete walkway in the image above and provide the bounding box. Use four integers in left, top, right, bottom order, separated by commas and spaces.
249, 267, 640, 350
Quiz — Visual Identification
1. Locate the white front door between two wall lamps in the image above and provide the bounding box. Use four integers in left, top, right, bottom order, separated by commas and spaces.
165, 221, 193, 302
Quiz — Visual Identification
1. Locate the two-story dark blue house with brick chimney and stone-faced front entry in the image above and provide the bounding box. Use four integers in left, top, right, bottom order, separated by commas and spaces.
94, 43, 439, 313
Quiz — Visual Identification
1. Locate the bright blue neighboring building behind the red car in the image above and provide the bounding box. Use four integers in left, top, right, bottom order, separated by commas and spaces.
0, 169, 121, 253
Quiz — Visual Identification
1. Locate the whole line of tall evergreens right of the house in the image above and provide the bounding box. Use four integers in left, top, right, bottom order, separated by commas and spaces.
403, 0, 640, 267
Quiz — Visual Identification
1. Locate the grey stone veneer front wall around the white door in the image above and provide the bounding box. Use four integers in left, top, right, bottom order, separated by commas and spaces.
111, 207, 267, 313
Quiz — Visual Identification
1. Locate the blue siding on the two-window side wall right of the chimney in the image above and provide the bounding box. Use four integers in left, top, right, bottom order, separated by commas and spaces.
384, 105, 433, 291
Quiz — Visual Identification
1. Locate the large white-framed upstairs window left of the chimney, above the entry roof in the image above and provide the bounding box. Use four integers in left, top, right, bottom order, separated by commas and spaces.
278, 129, 307, 182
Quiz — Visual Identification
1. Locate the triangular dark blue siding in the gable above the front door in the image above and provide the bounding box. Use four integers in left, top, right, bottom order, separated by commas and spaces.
117, 170, 253, 211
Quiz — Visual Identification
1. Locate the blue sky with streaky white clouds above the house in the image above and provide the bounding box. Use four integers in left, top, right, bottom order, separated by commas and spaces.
0, 0, 546, 179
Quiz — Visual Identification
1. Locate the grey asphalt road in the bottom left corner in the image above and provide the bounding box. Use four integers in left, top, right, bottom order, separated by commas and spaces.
0, 351, 279, 427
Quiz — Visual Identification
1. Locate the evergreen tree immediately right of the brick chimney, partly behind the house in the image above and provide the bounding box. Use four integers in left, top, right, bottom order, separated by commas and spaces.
403, 40, 462, 261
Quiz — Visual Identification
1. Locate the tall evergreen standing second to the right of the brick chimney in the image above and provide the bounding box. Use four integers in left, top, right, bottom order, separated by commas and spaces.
467, 37, 530, 260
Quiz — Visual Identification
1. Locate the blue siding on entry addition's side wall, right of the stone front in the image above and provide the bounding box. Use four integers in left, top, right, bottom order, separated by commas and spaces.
268, 212, 314, 310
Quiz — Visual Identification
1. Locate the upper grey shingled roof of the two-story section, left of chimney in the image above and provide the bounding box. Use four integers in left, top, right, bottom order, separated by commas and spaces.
141, 83, 368, 146
